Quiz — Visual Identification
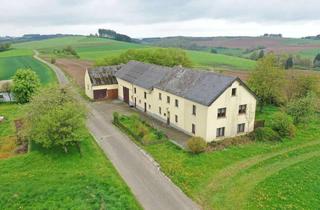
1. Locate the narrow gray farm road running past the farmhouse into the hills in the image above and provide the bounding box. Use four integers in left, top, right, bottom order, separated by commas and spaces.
34, 51, 199, 210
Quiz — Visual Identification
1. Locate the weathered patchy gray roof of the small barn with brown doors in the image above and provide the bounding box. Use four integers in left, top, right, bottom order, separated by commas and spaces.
88, 65, 122, 86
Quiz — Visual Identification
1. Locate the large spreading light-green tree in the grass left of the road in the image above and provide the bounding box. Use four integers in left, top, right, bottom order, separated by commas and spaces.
25, 86, 86, 154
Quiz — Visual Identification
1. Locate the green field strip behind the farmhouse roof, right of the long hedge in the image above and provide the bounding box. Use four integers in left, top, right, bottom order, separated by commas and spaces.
187, 51, 256, 70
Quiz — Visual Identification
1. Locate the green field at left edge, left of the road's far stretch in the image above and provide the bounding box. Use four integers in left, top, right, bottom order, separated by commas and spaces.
0, 49, 56, 84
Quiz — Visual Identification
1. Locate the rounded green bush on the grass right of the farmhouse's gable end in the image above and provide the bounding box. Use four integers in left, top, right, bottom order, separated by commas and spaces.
269, 112, 296, 137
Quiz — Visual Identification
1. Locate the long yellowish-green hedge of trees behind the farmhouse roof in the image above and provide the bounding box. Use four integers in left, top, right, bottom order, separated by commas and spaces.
96, 48, 192, 67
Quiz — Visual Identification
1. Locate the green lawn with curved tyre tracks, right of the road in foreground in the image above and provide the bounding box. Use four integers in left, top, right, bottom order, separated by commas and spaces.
116, 107, 320, 209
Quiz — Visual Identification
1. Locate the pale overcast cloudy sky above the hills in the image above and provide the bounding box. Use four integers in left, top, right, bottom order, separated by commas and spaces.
0, 0, 320, 36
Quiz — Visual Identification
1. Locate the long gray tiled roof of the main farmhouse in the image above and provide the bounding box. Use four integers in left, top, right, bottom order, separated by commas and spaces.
116, 61, 239, 106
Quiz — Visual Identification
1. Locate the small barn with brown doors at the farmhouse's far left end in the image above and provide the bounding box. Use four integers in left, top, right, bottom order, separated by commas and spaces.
85, 65, 122, 100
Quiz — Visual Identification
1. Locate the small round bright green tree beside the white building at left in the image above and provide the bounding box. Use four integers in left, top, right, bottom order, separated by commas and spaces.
12, 69, 40, 104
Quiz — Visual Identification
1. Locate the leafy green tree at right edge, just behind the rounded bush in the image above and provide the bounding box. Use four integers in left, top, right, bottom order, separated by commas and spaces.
287, 93, 317, 124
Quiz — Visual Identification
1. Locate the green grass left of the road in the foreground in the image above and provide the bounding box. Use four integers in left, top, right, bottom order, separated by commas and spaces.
0, 104, 141, 209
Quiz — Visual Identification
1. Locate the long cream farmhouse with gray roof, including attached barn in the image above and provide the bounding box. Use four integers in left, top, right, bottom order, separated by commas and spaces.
85, 61, 256, 142
